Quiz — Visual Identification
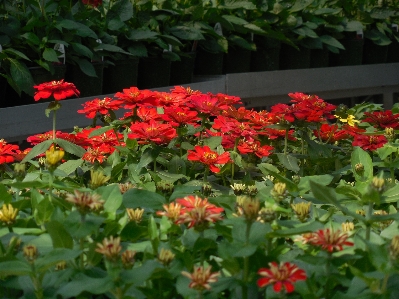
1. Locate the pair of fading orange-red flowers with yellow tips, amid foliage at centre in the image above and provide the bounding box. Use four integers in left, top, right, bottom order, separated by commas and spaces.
157, 195, 224, 228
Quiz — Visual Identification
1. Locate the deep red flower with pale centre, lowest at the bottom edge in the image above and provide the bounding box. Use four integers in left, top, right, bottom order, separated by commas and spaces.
257, 262, 306, 293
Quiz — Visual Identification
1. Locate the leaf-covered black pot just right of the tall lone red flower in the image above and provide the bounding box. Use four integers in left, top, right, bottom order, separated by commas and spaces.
67, 62, 104, 98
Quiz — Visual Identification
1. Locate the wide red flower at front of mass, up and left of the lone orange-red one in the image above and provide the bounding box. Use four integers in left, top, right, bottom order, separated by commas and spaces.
128, 120, 177, 144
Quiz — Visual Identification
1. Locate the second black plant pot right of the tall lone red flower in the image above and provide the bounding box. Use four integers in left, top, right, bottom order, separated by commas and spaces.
103, 57, 139, 94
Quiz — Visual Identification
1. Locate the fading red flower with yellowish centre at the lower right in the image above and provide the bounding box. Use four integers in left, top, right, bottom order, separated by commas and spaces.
306, 228, 354, 252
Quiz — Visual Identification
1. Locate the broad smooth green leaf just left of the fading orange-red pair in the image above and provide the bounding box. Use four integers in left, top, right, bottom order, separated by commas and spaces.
123, 189, 166, 211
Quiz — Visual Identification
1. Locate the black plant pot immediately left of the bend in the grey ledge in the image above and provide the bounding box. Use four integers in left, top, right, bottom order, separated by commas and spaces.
194, 49, 224, 75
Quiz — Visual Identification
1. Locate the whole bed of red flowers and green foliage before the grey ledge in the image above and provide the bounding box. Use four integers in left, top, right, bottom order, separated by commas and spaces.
0, 81, 399, 298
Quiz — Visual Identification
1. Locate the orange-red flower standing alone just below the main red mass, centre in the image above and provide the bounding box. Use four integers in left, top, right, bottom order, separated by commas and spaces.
187, 145, 230, 173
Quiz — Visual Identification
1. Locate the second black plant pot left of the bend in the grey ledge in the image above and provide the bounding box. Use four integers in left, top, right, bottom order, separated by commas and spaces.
169, 52, 196, 86
